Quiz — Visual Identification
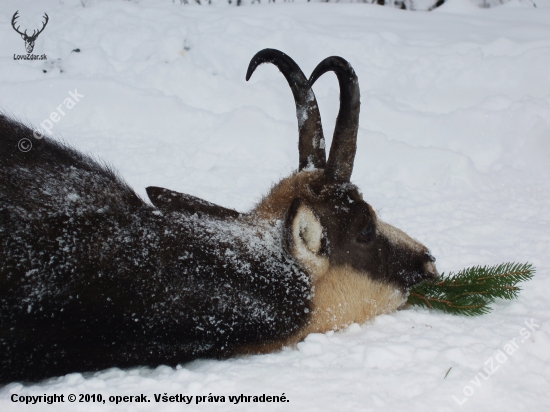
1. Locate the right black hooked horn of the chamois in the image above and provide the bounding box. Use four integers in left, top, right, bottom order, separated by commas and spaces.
308, 56, 361, 182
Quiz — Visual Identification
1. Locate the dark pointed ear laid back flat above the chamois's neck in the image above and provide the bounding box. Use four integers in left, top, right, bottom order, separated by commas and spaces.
145, 186, 240, 219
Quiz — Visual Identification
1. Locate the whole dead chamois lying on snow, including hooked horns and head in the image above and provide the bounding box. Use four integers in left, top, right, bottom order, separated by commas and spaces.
0, 49, 437, 383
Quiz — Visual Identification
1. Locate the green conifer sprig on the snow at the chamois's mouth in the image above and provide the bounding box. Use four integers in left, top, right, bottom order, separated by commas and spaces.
407, 263, 535, 316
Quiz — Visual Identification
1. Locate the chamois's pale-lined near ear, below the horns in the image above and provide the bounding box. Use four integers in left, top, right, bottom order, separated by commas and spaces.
284, 198, 328, 279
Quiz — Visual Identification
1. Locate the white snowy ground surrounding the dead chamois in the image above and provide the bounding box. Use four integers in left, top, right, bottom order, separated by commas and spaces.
0, 0, 550, 412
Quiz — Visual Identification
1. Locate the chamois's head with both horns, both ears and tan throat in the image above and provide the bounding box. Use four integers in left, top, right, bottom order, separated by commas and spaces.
147, 49, 437, 337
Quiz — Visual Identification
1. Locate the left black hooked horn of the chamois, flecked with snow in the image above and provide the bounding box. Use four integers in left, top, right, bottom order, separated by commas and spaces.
246, 49, 326, 170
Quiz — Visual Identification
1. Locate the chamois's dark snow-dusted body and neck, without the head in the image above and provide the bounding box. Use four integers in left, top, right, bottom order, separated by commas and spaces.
0, 116, 311, 382
